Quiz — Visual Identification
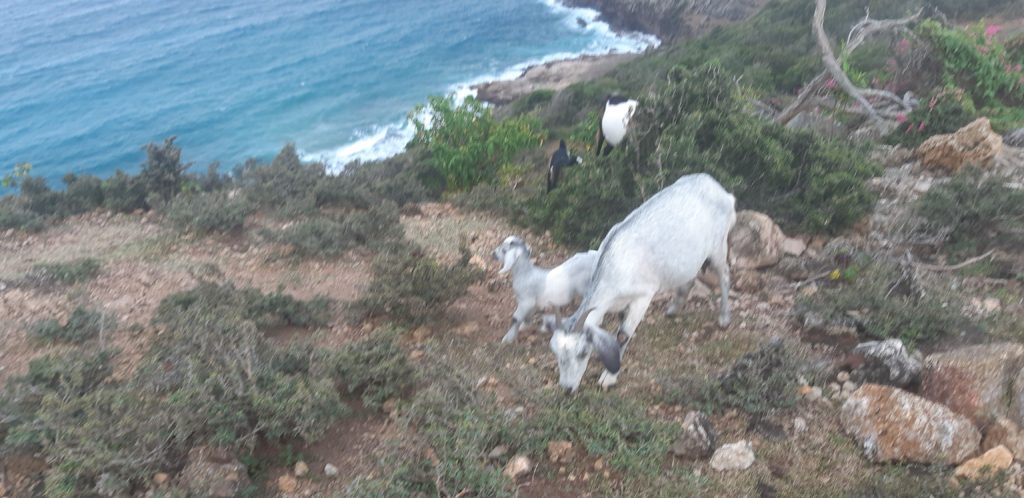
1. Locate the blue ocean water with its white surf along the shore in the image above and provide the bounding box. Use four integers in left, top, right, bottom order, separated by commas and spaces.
0, 0, 657, 188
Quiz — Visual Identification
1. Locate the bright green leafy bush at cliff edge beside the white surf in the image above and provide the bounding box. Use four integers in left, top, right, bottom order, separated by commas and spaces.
411, 95, 545, 191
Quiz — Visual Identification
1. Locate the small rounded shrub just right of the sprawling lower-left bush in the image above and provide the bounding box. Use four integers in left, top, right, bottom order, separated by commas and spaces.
336, 330, 414, 408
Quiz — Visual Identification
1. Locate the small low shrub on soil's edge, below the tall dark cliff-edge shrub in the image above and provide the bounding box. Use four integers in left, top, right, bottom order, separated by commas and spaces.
165, 192, 253, 235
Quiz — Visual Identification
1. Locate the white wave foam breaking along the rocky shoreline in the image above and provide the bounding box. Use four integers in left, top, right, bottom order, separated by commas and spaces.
311, 0, 662, 174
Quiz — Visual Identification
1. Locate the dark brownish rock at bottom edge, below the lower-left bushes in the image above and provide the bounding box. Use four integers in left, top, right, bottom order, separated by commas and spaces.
181, 447, 249, 498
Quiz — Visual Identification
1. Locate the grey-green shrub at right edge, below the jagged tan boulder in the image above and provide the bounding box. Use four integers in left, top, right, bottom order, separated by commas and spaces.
916, 168, 1024, 259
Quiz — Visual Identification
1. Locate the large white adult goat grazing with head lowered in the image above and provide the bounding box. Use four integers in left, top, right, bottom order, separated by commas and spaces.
551, 173, 736, 391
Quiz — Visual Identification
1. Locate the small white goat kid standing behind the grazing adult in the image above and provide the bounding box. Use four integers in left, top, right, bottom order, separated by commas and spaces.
494, 236, 597, 343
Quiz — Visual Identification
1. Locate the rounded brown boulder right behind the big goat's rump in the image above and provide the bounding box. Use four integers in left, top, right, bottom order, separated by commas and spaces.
729, 211, 785, 271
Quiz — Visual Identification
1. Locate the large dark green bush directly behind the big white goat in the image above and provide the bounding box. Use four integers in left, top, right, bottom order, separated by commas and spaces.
529, 65, 881, 246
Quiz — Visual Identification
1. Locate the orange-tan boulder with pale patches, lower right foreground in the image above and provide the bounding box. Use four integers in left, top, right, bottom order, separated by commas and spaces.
840, 384, 981, 465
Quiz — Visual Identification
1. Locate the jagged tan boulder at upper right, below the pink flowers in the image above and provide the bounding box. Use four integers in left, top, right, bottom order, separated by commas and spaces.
918, 118, 1002, 173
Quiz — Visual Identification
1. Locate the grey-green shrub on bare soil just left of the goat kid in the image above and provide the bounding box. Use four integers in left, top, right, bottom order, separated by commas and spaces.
349, 239, 482, 326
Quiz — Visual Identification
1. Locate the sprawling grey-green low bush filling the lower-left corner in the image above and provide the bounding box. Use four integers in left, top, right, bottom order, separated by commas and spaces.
0, 285, 347, 496
